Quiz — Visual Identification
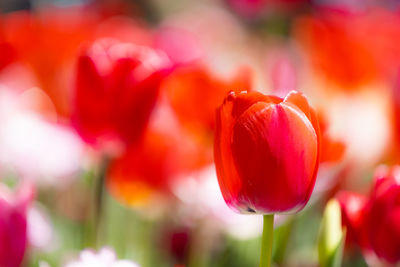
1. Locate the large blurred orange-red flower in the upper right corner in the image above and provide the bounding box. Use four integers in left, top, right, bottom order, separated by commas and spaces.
294, 10, 378, 90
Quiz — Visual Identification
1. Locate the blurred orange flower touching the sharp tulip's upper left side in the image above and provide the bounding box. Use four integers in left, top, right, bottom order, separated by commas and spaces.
164, 65, 251, 134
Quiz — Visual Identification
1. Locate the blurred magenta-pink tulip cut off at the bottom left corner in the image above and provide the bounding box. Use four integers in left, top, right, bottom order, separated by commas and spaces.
0, 184, 32, 267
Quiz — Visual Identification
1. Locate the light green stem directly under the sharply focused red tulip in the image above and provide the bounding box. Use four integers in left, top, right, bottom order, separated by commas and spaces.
260, 214, 274, 267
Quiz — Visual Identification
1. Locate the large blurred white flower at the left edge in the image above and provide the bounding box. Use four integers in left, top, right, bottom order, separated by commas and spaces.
0, 87, 84, 186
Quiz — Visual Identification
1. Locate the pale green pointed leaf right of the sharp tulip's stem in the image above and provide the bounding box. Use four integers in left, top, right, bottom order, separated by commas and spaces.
318, 200, 346, 267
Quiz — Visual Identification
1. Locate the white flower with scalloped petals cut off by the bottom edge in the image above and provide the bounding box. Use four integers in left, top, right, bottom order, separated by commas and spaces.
65, 247, 139, 267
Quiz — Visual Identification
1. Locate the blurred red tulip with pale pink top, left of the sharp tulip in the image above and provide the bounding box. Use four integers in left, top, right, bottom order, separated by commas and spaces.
73, 39, 167, 148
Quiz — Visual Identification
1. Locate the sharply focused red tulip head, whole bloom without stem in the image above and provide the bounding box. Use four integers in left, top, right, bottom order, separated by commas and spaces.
214, 91, 320, 214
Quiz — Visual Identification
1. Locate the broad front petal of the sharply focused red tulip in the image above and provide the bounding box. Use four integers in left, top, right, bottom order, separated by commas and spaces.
231, 102, 318, 213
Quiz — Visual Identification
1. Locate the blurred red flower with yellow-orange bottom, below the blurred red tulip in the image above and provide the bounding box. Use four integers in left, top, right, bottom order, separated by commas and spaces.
107, 124, 210, 207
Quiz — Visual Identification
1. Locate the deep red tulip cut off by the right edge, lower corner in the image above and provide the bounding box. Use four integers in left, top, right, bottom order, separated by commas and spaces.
366, 166, 400, 264
